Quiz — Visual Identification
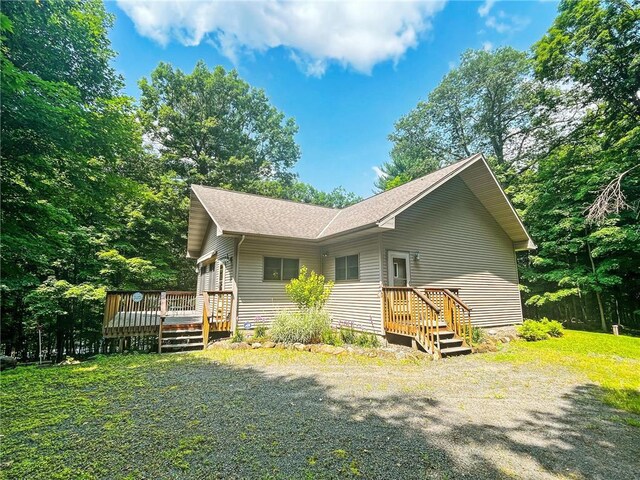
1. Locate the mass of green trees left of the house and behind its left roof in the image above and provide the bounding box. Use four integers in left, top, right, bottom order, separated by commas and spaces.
0, 0, 358, 359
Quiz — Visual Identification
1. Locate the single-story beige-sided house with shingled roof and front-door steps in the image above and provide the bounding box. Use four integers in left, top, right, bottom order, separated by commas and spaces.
105, 155, 534, 351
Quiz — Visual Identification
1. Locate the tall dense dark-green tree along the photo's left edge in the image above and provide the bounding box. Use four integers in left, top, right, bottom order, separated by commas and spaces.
0, 1, 156, 358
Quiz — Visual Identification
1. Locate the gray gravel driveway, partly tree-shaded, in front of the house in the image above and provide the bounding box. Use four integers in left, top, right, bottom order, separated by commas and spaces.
87, 350, 640, 480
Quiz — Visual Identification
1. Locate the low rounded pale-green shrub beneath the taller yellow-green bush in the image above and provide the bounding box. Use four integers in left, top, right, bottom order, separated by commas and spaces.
271, 308, 331, 343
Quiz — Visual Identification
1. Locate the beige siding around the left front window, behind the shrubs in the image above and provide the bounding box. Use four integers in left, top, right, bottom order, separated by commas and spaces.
238, 238, 320, 328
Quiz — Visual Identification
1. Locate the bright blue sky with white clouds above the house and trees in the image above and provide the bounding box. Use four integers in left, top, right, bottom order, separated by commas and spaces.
107, 0, 557, 196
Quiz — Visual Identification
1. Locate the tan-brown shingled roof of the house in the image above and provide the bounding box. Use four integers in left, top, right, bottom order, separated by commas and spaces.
189, 155, 528, 251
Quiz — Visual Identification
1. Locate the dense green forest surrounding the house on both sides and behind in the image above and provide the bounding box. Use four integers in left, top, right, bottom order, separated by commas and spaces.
0, 0, 640, 358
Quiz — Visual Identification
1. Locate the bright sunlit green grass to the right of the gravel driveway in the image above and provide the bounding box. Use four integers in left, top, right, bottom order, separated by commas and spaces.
487, 330, 640, 416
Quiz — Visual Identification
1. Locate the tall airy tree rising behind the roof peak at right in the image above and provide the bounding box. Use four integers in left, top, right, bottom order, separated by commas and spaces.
376, 47, 560, 190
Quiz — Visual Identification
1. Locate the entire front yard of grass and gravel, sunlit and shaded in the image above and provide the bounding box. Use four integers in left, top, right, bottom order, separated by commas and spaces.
0, 332, 640, 480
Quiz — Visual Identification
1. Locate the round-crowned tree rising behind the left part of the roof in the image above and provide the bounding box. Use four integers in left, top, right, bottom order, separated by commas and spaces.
140, 62, 300, 190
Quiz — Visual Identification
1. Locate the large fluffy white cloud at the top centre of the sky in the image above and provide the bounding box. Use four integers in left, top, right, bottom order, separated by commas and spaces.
118, 0, 446, 76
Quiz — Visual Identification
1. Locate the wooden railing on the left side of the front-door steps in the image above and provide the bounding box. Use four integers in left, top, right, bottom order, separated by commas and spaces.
382, 287, 440, 353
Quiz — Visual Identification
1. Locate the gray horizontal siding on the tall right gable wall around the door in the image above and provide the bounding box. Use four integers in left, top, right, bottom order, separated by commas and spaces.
382, 177, 522, 326
